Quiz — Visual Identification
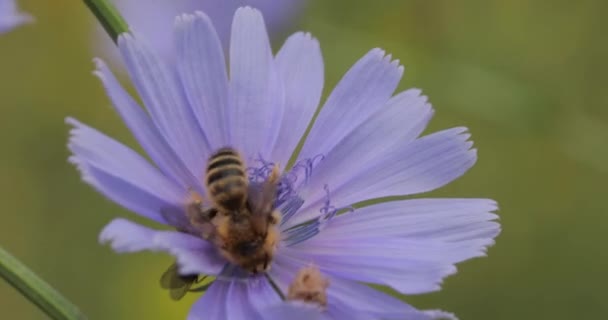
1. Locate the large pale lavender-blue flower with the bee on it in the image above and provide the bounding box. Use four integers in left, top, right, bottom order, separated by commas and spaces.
67, 8, 500, 320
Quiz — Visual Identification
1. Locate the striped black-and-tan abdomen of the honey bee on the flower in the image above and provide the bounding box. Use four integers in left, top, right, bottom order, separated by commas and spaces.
206, 148, 248, 211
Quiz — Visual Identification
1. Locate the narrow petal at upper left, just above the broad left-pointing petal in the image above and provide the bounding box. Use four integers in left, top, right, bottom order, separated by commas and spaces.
94, 59, 201, 189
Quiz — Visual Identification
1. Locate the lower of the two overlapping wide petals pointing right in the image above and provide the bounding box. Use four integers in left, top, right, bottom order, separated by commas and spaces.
281, 220, 494, 294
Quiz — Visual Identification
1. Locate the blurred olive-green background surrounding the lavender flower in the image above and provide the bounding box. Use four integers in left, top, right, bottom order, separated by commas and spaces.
0, 0, 608, 320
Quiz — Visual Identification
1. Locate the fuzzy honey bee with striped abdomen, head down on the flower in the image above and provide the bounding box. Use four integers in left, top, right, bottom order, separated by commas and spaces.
186, 148, 281, 274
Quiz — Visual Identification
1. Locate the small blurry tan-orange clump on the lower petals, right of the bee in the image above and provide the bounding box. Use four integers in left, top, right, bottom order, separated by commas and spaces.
287, 266, 329, 308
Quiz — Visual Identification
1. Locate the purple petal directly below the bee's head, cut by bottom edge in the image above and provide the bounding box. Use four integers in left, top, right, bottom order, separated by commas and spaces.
188, 277, 281, 320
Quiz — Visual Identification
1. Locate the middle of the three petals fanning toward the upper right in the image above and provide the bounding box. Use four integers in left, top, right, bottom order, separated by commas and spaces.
300, 89, 433, 209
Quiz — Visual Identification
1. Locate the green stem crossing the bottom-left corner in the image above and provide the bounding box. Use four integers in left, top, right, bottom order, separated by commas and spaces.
0, 248, 86, 320
